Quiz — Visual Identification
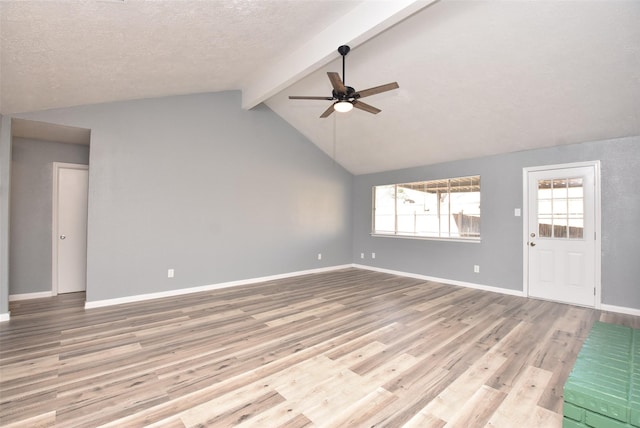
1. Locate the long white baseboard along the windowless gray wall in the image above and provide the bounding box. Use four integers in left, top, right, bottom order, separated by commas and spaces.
84, 264, 353, 309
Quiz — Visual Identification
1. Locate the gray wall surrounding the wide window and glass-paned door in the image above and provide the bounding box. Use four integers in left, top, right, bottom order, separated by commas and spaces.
353, 137, 640, 309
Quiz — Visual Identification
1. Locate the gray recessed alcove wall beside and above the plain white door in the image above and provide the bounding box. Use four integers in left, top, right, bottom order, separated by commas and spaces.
9, 138, 89, 295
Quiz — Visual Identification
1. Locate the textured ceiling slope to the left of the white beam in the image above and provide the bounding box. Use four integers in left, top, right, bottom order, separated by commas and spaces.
0, 0, 360, 113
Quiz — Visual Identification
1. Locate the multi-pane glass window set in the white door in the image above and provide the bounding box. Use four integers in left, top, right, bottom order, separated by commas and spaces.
538, 177, 584, 239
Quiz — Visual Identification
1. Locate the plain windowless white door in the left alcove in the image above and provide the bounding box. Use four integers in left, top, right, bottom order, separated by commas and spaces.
53, 163, 89, 294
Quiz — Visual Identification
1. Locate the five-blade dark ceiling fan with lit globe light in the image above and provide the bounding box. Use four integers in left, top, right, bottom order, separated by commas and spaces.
289, 45, 399, 118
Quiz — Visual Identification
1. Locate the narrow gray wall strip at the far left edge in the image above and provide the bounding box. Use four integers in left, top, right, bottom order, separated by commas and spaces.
0, 115, 11, 315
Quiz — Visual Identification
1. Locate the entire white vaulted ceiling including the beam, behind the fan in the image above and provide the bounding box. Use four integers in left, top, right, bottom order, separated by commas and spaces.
0, 0, 640, 174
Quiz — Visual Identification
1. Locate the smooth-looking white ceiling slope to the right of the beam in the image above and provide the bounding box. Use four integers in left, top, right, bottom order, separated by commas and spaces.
267, 1, 640, 174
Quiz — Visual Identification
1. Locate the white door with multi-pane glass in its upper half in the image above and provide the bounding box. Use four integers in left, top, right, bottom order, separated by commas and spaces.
526, 165, 599, 307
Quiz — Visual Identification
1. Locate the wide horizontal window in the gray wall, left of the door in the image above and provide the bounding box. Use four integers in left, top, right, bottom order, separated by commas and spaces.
373, 175, 480, 240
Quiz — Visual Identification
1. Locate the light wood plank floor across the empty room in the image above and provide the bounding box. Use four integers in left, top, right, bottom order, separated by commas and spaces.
0, 269, 640, 428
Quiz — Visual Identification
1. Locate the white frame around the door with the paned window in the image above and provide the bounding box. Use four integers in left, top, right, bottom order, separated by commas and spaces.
522, 160, 602, 309
